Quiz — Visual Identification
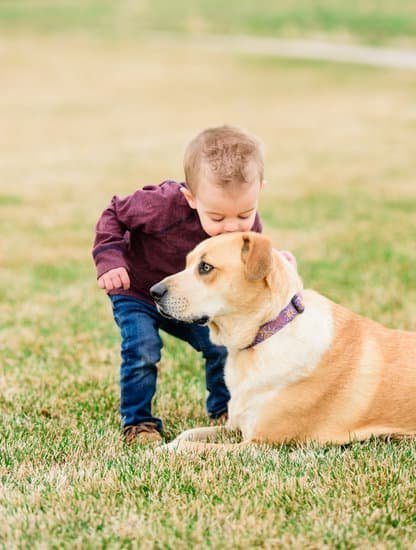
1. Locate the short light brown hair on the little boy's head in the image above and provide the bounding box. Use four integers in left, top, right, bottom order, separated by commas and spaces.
184, 125, 264, 193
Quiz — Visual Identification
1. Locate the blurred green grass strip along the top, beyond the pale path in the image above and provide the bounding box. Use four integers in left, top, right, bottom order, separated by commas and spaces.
0, 0, 416, 44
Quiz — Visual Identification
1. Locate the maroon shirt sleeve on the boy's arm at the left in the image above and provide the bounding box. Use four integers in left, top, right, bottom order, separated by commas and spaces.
92, 184, 171, 278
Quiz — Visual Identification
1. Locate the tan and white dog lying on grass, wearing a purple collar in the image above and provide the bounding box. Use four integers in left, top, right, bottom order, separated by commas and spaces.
152, 233, 416, 450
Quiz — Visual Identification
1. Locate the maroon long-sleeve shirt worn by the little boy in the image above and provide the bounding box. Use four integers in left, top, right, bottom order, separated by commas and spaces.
92, 180, 262, 303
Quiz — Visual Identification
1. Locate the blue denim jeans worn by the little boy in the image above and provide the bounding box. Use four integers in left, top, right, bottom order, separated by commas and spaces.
109, 294, 230, 431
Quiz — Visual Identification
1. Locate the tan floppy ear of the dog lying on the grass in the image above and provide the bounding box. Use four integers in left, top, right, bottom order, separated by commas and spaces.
241, 232, 273, 281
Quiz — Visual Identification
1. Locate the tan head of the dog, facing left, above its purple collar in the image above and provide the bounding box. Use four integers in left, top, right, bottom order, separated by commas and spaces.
150, 232, 302, 338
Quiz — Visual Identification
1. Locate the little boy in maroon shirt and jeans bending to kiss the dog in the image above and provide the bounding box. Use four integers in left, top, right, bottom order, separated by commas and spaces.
93, 126, 263, 444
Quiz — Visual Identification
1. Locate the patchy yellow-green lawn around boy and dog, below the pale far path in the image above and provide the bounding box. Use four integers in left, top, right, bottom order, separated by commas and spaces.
0, 2, 416, 548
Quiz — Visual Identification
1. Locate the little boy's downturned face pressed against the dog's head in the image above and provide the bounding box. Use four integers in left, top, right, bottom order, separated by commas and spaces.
182, 172, 261, 237
